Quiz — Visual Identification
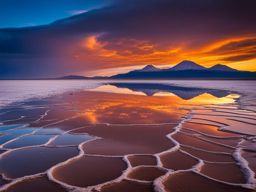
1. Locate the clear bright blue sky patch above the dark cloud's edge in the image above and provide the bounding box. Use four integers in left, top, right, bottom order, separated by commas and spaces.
0, 0, 107, 28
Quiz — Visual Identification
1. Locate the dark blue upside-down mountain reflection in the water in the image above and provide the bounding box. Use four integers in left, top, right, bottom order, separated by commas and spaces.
109, 83, 229, 100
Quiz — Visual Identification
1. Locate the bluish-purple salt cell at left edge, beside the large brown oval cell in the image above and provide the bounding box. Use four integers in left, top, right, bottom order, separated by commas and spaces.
0, 147, 78, 179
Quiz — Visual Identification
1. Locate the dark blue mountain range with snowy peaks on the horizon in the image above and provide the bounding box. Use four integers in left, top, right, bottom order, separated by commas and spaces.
110, 60, 256, 79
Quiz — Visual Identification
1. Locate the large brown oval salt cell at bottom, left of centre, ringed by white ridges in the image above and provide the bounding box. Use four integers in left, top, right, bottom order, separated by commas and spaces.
53, 156, 127, 187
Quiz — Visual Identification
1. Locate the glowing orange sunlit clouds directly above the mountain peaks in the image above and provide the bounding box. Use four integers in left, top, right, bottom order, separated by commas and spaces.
74, 35, 256, 75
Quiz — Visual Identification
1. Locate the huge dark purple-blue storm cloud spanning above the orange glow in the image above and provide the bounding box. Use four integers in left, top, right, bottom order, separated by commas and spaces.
0, 0, 256, 77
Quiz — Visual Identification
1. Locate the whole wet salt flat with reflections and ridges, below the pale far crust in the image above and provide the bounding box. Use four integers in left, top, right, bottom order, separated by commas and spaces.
0, 80, 256, 192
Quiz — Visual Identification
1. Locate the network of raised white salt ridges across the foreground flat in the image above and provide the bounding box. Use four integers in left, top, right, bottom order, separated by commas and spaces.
0, 80, 256, 192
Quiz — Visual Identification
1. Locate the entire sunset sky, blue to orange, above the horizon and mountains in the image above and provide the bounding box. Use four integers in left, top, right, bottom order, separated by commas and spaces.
0, 0, 256, 79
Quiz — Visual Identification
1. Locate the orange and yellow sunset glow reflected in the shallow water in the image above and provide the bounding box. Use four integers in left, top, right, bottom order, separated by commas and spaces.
66, 89, 238, 124
